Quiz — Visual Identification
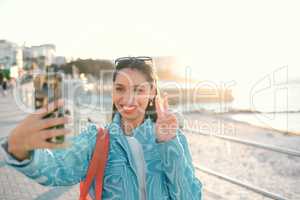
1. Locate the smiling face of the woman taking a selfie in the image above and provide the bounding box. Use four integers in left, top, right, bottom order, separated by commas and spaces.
112, 68, 155, 121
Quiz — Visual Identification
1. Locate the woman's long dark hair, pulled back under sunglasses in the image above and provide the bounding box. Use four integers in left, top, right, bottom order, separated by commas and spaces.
112, 57, 158, 122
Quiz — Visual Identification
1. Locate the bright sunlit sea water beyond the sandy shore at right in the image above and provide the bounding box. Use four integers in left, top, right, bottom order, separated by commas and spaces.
229, 82, 300, 134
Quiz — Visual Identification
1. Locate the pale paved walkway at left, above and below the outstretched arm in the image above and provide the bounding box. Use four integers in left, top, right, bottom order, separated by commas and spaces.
0, 96, 79, 200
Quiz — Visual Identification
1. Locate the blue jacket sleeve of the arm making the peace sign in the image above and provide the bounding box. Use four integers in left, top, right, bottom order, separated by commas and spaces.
158, 129, 202, 200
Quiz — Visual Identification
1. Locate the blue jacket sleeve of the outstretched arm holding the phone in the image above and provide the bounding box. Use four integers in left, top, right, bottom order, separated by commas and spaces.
0, 124, 98, 186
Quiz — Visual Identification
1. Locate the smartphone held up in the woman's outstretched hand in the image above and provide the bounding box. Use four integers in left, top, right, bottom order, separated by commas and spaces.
33, 72, 65, 144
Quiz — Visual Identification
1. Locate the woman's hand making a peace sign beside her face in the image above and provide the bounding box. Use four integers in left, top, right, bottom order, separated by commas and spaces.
155, 93, 178, 142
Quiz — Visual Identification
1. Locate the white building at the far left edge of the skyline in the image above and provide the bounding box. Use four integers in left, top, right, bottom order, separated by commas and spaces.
0, 40, 23, 69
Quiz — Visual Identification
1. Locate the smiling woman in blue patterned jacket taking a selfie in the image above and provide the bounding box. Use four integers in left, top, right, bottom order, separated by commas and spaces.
3, 57, 202, 200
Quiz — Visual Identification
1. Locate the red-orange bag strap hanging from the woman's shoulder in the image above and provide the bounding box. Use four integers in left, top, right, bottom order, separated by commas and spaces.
79, 128, 109, 200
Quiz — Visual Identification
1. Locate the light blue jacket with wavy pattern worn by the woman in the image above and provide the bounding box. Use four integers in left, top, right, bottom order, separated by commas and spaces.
0, 113, 202, 200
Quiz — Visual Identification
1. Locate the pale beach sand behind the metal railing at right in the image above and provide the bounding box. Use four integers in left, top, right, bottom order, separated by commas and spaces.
184, 113, 300, 200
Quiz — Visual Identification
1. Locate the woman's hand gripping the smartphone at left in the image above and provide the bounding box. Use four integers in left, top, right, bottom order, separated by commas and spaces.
8, 101, 71, 160
